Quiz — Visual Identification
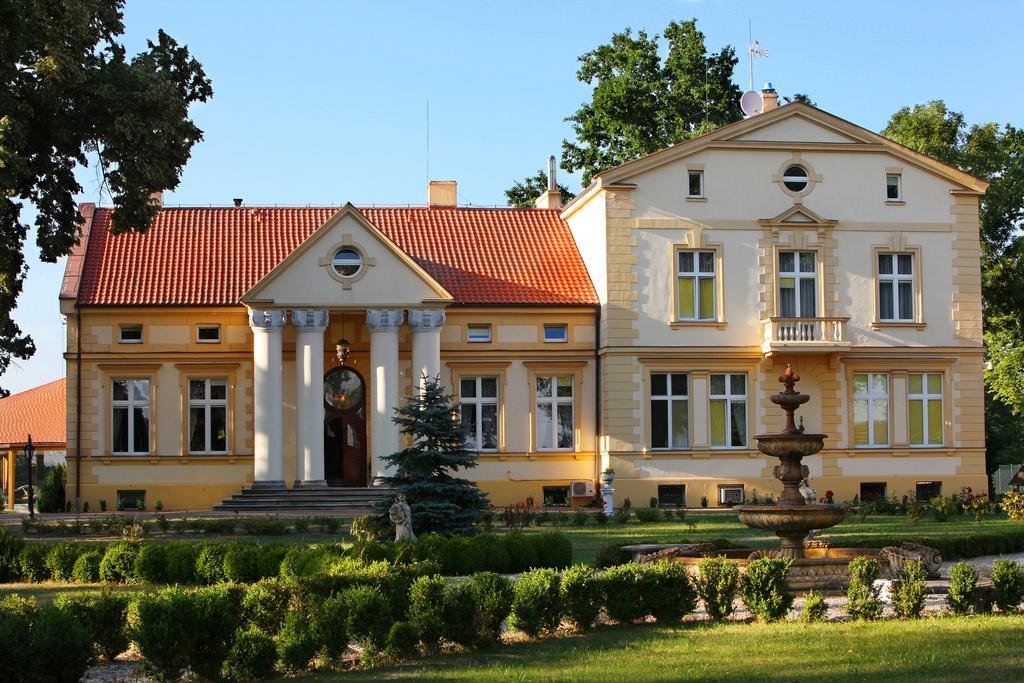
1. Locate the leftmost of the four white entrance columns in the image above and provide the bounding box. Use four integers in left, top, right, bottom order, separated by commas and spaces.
249, 310, 288, 488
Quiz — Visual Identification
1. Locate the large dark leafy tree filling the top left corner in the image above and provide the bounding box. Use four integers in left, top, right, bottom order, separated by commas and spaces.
0, 0, 213, 392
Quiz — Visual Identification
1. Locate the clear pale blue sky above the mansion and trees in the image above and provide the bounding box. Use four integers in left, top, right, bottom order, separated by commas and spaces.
0, 0, 1024, 391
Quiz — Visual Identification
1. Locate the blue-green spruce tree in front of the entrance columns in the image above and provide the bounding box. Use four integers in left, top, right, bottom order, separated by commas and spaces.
381, 377, 489, 536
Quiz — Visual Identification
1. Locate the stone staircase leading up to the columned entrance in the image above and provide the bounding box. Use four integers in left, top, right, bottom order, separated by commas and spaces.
213, 486, 393, 517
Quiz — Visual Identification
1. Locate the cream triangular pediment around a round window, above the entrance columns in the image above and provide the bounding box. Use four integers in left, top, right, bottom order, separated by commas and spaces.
242, 204, 453, 308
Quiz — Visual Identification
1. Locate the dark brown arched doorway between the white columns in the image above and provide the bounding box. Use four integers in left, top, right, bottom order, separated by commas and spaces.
324, 367, 367, 486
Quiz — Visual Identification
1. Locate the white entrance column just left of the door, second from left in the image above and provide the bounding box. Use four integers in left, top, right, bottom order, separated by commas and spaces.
292, 309, 331, 487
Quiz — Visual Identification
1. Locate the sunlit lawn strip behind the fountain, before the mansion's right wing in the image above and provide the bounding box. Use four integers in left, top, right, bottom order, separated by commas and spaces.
527, 512, 1024, 563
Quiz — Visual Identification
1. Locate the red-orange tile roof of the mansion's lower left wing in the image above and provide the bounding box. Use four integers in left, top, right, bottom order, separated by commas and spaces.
75, 207, 597, 305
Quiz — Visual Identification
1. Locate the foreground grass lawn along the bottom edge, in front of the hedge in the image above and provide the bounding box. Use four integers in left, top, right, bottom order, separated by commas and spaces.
306, 615, 1024, 683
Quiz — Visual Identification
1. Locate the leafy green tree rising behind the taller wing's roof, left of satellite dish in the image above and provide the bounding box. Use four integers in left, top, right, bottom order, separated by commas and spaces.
561, 19, 742, 185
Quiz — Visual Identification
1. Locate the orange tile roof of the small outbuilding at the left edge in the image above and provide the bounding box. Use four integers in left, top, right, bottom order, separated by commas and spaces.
0, 380, 68, 447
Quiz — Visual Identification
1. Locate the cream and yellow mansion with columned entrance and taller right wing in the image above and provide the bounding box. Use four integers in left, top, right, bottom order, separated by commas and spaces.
60, 98, 988, 510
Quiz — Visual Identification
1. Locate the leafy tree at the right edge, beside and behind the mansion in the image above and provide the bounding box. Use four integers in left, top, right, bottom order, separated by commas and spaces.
882, 100, 1024, 468
